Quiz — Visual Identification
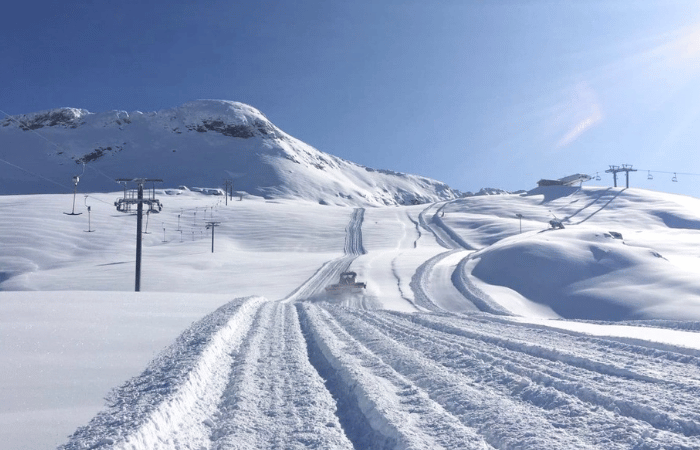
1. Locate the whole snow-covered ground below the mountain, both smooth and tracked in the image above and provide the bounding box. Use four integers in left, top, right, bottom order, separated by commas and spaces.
0, 187, 700, 449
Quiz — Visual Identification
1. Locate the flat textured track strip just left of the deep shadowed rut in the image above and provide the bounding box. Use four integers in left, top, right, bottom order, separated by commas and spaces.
206, 302, 352, 450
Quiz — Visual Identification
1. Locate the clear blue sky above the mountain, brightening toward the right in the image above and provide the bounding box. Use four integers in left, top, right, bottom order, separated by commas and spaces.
0, 0, 700, 197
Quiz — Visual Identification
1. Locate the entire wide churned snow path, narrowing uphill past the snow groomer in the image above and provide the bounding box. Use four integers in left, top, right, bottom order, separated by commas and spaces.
61, 205, 700, 450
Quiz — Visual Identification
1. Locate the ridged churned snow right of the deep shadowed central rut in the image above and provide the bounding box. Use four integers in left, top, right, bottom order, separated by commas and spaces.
300, 303, 700, 449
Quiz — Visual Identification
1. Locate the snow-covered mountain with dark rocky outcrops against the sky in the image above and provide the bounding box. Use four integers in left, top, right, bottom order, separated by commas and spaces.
0, 100, 459, 205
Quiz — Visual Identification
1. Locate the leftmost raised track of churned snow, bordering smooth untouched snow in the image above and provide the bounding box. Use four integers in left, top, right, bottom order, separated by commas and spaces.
59, 297, 264, 450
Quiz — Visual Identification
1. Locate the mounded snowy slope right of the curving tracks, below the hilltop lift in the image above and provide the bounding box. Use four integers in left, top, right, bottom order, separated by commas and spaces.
443, 187, 700, 320
